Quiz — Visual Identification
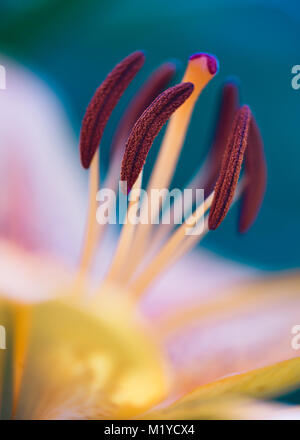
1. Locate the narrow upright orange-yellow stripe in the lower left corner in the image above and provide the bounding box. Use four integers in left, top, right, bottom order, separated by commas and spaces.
12, 305, 31, 417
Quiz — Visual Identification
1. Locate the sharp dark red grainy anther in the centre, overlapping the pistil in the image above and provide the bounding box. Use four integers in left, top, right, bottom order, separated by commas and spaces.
121, 83, 194, 191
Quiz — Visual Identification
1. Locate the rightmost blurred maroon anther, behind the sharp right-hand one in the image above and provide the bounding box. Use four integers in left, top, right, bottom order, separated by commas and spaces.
239, 118, 267, 232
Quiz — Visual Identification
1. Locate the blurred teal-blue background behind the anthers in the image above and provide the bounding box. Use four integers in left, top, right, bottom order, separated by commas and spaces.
0, 0, 300, 270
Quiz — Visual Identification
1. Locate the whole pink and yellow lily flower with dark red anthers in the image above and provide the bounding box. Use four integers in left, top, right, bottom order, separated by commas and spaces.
0, 52, 300, 419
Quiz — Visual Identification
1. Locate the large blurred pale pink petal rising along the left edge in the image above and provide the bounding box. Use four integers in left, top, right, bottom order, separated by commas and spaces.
0, 59, 85, 262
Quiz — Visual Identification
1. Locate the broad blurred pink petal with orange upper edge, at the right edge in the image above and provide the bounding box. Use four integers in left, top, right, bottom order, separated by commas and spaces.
156, 273, 300, 393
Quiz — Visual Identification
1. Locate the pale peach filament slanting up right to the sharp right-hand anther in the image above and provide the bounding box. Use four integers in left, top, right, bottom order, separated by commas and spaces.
129, 193, 214, 297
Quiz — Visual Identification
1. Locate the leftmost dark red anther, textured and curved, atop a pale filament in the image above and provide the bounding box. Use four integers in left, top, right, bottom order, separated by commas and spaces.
80, 51, 145, 168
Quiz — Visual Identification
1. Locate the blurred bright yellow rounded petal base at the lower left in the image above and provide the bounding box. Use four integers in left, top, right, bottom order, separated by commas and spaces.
12, 292, 167, 419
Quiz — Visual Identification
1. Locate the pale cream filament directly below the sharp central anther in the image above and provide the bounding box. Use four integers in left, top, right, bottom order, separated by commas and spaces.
107, 171, 143, 280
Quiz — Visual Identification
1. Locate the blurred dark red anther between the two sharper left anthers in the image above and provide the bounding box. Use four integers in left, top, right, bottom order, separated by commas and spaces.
111, 63, 176, 156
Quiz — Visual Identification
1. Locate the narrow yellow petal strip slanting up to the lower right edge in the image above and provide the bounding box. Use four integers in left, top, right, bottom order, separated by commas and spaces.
149, 357, 300, 420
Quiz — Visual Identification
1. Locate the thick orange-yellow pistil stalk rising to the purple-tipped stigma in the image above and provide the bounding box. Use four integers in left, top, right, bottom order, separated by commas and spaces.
128, 57, 214, 273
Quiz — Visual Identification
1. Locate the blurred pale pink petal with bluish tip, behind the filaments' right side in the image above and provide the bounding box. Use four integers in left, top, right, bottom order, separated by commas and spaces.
140, 249, 258, 325
